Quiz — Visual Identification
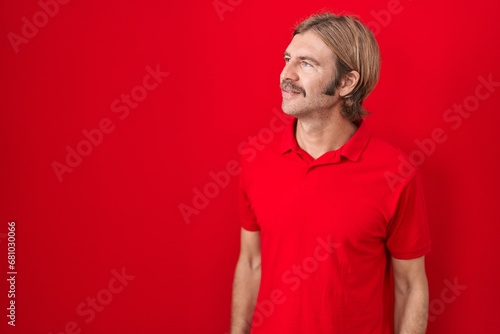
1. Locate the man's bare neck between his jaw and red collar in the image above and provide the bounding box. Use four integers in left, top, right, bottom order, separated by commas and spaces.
295, 112, 357, 159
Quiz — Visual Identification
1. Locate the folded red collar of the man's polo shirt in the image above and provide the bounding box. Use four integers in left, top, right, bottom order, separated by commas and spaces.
280, 118, 370, 162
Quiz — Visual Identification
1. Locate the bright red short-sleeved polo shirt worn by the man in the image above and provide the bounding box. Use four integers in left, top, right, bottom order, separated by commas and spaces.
240, 120, 430, 334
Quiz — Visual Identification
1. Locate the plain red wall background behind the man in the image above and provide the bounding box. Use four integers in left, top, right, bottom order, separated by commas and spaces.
0, 0, 500, 334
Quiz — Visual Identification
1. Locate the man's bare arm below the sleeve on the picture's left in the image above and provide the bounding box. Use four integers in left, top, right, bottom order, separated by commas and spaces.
231, 228, 261, 334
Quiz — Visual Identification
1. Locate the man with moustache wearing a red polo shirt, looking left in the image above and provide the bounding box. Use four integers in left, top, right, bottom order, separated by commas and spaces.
231, 13, 430, 334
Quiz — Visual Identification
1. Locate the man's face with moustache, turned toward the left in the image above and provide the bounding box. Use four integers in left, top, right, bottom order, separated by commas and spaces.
280, 31, 339, 118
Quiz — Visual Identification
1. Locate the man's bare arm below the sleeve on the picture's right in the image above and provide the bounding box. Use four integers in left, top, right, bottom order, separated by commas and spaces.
392, 256, 429, 334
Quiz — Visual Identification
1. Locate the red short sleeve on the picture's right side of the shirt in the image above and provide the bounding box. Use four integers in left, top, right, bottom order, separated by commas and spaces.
386, 173, 431, 260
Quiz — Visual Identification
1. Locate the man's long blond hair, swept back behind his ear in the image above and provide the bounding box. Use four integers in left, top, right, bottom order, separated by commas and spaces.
293, 13, 380, 122
